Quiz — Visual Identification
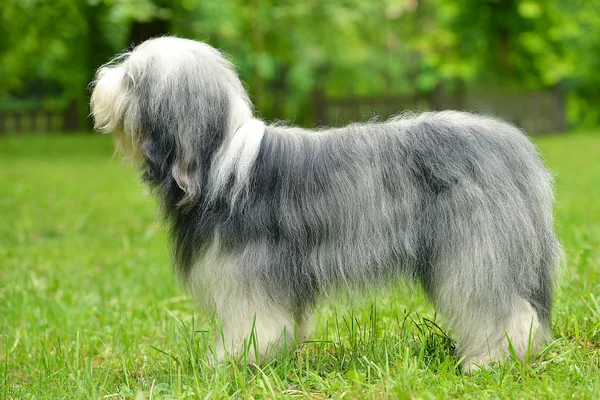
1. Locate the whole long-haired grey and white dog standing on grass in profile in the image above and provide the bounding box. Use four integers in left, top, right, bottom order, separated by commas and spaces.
91, 37, 561, 372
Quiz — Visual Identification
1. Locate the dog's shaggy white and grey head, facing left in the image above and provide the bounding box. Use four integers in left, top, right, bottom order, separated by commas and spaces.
90, 37, 252, 204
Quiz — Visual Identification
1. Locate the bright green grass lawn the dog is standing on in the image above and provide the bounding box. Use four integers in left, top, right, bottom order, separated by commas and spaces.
0, 134, 600, 399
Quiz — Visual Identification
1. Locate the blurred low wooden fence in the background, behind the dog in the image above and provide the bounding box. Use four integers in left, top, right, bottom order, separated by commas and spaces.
0, 88, 567, 134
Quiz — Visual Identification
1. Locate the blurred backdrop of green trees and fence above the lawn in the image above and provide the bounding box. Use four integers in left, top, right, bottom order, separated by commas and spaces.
0, 0, 600, 133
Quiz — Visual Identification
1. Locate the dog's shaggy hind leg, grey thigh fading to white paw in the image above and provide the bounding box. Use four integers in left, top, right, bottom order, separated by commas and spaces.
422, 184, 552, 373
